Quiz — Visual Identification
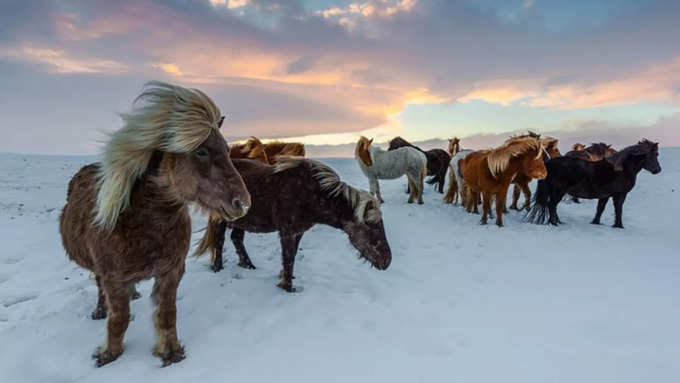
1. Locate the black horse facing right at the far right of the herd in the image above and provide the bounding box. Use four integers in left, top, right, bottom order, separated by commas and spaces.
525, 139, 661, 228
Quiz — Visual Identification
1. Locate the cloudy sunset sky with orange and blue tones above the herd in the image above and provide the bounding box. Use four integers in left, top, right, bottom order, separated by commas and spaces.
0, 0, 680, 155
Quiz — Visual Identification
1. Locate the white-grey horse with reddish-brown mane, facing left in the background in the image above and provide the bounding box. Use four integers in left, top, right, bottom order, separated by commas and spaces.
354, 136, 427, 205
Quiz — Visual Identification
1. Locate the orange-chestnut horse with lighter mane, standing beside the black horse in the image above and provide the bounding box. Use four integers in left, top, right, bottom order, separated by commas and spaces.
461, 137, 546, 227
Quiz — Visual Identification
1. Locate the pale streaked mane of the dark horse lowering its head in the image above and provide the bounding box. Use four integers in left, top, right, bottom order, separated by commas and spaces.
274, 156, 382, 222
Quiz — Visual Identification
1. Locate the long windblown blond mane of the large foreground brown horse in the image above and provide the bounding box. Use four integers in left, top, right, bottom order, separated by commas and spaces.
94, 81, 222, 230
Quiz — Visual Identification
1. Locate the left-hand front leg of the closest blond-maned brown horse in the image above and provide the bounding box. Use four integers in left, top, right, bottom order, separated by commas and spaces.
92, 278, 130, 367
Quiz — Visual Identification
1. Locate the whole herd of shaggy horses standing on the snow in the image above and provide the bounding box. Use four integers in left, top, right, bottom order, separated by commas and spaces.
59, 81, 661, 366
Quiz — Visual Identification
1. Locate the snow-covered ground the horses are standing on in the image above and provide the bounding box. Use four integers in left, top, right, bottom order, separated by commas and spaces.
0, 149, 680, 383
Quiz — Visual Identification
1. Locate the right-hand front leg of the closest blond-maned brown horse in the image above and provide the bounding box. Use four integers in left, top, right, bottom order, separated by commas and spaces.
151, 263, 184, 367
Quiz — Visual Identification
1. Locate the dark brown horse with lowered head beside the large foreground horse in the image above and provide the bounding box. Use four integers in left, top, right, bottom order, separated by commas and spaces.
196, 157, 392, 292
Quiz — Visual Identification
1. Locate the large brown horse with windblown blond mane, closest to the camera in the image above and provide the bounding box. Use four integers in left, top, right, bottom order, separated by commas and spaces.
59, 81, 250, 367
